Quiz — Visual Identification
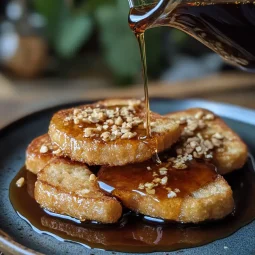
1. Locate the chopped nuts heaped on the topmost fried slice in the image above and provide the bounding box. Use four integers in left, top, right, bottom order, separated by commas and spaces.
64, 100, 146, 141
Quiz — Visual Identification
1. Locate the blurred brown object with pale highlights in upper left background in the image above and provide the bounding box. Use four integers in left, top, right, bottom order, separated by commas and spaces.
0, 0, 48, 78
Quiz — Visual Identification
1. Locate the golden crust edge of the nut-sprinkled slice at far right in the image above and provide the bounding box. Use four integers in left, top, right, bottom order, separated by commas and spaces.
166, 108, 248, 175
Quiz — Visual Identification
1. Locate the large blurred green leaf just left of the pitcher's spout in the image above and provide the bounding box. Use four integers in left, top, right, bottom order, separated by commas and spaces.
95, 0, 141, 79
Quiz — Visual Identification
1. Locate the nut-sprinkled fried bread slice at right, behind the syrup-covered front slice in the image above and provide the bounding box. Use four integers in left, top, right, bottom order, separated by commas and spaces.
167, 108, 248, 175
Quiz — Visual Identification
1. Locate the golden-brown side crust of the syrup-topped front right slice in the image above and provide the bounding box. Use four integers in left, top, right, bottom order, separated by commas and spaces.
99, 173, 234, 223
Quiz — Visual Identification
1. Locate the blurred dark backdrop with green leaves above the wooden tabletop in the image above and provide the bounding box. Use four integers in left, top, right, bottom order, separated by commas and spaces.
0, 0, 229, 82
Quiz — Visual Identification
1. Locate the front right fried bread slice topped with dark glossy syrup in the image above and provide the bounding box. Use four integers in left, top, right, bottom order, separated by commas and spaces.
98, 160, 234, 223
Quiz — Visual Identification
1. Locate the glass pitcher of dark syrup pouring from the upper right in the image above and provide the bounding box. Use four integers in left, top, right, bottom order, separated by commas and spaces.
129, 0, 255, 71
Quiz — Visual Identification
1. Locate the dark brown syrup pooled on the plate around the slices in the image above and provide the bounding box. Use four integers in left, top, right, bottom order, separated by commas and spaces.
10, 156, 255, 252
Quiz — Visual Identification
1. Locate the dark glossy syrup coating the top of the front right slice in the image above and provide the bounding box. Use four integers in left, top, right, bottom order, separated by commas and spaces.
98, 160, 217, 199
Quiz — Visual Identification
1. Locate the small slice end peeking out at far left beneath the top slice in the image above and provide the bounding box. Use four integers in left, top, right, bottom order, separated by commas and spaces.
25, 134, 54, 174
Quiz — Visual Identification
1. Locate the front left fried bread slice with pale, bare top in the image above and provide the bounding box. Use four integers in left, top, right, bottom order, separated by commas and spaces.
34, 158, 122, 223
